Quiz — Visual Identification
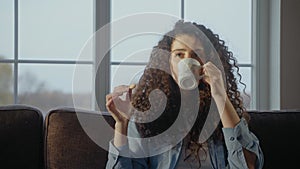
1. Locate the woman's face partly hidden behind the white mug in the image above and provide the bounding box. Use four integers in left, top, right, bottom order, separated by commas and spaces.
170, 35, 204, 83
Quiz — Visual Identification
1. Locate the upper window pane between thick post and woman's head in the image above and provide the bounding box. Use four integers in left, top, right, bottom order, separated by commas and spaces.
111, 0, 181, 62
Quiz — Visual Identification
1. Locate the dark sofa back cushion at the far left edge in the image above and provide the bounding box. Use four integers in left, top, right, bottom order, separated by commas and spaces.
0, 105, 43, 169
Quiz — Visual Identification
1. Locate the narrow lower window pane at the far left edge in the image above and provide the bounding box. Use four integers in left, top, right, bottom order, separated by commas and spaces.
0, 63, 14, 106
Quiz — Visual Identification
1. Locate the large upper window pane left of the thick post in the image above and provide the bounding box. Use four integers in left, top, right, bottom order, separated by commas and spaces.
19, 0, 93, 60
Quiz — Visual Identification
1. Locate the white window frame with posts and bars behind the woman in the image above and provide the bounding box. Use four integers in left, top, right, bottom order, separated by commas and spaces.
0, 0, 281, 110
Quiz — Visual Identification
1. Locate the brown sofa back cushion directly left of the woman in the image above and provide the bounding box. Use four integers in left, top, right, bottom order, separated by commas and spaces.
45, 108, 114, 169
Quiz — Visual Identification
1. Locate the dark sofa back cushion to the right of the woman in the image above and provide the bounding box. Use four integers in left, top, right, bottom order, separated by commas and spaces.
249, 110, 300, 169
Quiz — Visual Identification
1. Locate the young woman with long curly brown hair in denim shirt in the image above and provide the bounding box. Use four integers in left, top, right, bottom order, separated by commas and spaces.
106, 20, 264, 169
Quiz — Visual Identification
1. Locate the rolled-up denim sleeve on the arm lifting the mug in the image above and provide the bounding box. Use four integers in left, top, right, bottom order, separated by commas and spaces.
222, 118, 264, 169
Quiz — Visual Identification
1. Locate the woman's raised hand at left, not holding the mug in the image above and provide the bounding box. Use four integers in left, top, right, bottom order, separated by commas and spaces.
106, 84, 135, 124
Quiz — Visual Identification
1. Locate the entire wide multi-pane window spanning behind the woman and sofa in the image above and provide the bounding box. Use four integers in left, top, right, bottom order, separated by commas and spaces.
0, 0, 268, 112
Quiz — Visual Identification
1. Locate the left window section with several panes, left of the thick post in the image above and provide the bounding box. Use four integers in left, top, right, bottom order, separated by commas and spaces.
0, 0, 94, 113
